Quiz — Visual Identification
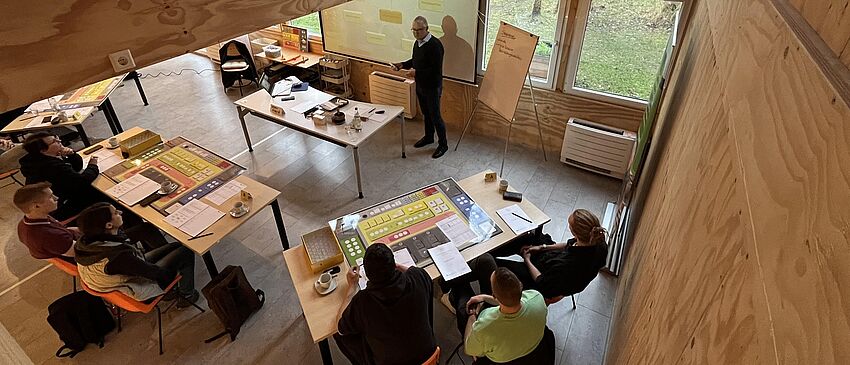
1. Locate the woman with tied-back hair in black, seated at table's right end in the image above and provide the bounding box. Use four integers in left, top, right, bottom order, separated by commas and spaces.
498, 209, 608, 303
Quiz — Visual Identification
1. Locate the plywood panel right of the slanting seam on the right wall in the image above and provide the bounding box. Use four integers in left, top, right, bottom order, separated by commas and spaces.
711, 0, 850, 364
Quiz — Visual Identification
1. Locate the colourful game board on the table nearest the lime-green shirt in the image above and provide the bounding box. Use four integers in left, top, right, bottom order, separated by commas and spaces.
328, 179, 502, 267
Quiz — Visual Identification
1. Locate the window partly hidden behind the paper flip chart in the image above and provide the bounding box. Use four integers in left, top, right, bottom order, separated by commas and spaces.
481, 0, 563, 88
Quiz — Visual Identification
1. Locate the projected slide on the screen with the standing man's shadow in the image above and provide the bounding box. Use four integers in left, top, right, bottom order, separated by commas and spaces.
321, 0, 478, 82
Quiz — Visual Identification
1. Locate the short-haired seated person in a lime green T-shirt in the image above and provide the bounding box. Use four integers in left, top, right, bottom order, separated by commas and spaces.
463, 267, 554, 364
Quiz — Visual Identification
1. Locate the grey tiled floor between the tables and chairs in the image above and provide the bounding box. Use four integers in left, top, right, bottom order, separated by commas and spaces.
0, 54, 619, 364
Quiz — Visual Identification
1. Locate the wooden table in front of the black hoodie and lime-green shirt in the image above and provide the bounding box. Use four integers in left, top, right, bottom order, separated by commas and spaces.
283, 171, 550, 364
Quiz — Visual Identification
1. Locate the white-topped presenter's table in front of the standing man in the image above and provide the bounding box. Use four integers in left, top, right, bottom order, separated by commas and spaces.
234, 87, 407, 199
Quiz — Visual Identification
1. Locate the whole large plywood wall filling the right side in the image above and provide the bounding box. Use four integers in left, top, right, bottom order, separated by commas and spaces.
607, 0, 850, 364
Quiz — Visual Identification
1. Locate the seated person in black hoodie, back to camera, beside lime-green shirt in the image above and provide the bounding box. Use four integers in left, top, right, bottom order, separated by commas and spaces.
334, 243, 437, 365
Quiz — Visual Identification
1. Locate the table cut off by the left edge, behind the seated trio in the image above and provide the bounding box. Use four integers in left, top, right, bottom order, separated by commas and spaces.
0, 73, 127, 147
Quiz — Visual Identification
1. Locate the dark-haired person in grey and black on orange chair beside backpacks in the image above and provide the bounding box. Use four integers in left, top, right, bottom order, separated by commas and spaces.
74, 203, 199, 307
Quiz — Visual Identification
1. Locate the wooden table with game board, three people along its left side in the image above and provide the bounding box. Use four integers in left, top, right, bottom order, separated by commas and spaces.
80, 127, 289, 277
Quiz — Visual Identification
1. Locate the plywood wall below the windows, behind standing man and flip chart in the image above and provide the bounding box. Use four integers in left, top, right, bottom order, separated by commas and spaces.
344, 61, 643, 153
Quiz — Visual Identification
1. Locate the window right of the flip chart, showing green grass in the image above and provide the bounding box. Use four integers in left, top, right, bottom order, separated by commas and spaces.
564, 0, 681, 106
